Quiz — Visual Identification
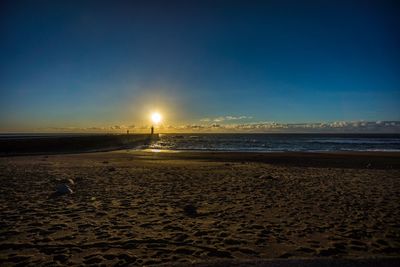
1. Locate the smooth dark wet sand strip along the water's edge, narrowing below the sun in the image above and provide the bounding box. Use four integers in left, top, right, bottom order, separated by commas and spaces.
123, 150, 400, 169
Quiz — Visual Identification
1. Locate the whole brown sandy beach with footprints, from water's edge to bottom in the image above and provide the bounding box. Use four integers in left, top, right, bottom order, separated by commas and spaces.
0, 151, 400, 266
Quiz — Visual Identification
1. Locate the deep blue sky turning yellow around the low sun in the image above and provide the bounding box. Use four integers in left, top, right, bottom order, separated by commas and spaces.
0, 0, 400, 132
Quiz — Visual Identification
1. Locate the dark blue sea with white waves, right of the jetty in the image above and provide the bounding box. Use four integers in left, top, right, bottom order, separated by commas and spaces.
150, 134, 400, 152
